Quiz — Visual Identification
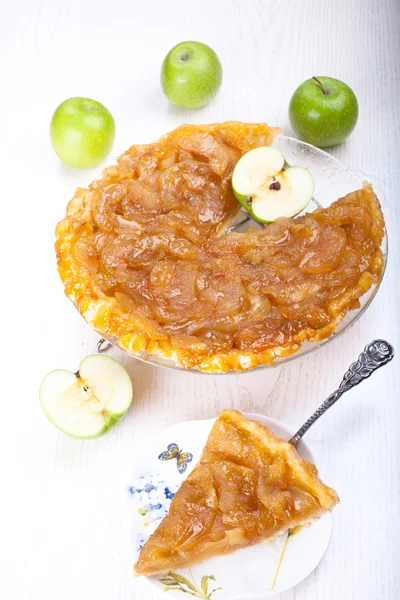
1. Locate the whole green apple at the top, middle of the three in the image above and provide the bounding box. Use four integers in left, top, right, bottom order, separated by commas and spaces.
161, 42, 222, 108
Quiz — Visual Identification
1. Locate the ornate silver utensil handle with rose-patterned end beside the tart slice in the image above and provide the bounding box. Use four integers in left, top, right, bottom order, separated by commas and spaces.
289, 340, 394, 446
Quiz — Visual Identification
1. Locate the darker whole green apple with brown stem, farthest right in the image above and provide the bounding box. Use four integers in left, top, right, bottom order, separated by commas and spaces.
289, 77, 358, 148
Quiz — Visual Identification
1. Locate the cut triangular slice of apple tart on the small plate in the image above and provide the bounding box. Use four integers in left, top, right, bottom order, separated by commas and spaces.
135, 410, 339, 575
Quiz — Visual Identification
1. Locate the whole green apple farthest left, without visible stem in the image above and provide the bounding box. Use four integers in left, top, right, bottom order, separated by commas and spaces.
50, 98, 115, 168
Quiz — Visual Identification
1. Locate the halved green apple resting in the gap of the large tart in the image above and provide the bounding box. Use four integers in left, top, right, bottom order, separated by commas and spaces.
232, 146, 314, 223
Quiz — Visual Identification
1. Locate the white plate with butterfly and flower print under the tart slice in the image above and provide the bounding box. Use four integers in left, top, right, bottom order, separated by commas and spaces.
126, 414, 332, 600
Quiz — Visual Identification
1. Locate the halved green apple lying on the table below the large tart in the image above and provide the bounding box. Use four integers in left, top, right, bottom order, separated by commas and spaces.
39, 354, 133, 439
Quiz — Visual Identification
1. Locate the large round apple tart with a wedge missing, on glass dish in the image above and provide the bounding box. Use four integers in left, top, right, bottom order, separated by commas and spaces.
56, 122, 384, 372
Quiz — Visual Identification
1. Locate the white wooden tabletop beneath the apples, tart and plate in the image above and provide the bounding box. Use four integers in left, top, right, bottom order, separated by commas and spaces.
0, 0, 400, 600
